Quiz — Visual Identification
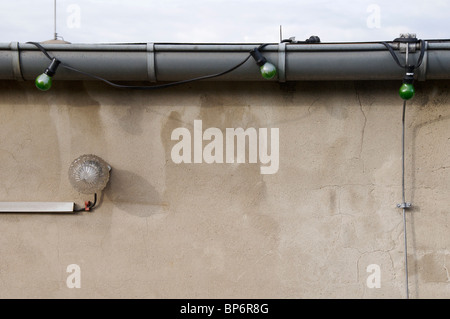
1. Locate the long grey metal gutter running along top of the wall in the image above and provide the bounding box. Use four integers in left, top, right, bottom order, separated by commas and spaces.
0, 40, 450, 83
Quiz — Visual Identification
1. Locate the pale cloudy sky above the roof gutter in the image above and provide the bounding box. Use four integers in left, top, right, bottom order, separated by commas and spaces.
0, 0, 450, 43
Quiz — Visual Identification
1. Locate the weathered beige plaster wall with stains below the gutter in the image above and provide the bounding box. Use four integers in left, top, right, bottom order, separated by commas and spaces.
0, 80, 450, 298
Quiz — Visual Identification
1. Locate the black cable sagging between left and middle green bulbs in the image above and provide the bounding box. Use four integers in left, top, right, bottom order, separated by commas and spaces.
27, 42, 269, 90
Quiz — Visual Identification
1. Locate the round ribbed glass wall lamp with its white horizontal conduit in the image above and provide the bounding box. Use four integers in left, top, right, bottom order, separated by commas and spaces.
0, 154, 111, 213
